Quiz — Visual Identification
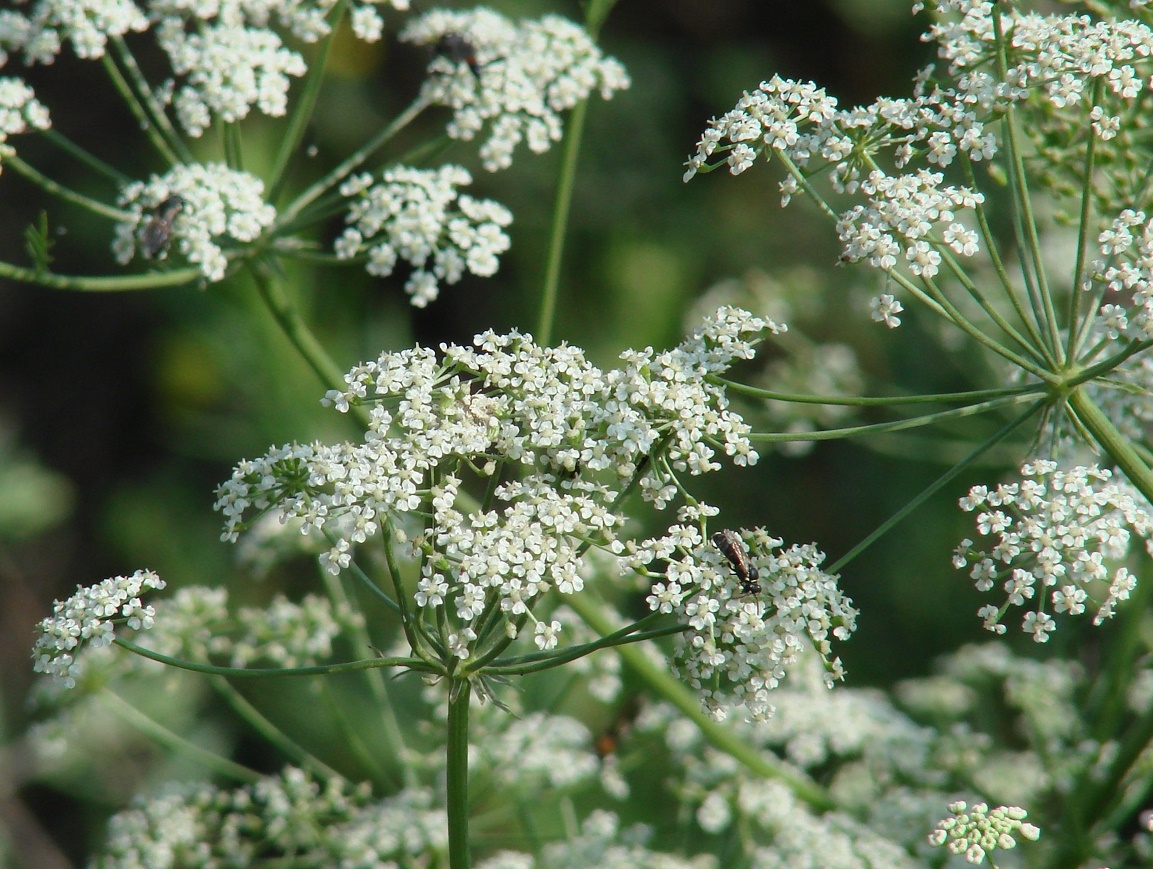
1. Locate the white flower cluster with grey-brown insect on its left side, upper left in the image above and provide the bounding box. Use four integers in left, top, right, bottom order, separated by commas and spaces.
113, 164, 277, 281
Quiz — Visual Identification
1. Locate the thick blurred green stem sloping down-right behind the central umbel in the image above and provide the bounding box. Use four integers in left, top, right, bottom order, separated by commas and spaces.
566, 595, 834, 811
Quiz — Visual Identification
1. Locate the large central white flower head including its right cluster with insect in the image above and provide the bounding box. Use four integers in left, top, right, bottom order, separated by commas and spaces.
209, 308, 854, 715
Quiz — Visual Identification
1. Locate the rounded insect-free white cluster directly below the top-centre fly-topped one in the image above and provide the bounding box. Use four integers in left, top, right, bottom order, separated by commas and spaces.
336, 166, 512, 308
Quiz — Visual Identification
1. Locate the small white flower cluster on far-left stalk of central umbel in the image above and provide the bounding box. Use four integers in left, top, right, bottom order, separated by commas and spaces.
32, 570, 165, 688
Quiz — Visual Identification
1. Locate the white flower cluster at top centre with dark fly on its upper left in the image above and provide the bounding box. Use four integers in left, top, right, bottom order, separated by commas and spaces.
400, 7, 630, 172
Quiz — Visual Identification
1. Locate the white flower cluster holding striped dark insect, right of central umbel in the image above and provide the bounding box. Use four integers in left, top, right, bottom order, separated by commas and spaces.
621, 524, 857, 720
